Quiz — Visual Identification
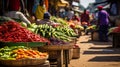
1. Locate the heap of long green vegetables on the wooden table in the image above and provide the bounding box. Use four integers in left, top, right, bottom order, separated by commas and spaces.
35, 24, 76, 43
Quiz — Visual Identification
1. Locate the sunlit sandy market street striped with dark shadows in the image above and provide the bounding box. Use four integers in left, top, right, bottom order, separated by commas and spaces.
69, 35, 120, 67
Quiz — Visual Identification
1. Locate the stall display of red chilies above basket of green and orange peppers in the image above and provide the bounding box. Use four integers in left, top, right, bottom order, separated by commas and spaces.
0, 18, 50, 67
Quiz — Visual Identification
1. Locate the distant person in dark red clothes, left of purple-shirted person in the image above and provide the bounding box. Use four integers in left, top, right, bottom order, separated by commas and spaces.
81, 9, 90, 35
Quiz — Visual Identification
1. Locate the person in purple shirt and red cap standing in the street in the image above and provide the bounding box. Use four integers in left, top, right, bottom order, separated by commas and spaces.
97, 6, 109, 42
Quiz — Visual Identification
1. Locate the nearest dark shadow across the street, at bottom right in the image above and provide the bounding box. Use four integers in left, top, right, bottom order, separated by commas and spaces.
88, 56, 120, 62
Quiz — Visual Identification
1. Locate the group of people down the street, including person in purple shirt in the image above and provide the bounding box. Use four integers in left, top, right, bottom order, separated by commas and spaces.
58, 6, 110, 42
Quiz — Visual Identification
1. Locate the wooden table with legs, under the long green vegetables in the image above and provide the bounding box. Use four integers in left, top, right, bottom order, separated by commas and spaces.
38, 44, 73, 67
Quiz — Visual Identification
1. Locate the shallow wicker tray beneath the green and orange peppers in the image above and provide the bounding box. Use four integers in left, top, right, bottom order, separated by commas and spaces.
0, 57, 48, 66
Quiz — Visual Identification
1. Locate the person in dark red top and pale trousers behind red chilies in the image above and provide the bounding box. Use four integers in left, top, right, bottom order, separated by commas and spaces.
4, 0, 31, 25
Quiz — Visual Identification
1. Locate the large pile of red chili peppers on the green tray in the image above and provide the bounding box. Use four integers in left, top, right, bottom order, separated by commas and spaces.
0, 21, 50, 43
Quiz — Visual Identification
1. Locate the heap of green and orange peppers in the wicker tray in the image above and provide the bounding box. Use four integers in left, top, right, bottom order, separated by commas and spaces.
0, 46, 48, 60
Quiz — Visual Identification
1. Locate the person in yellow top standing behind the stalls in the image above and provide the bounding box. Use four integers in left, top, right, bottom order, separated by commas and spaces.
35, 0, 46, 20
